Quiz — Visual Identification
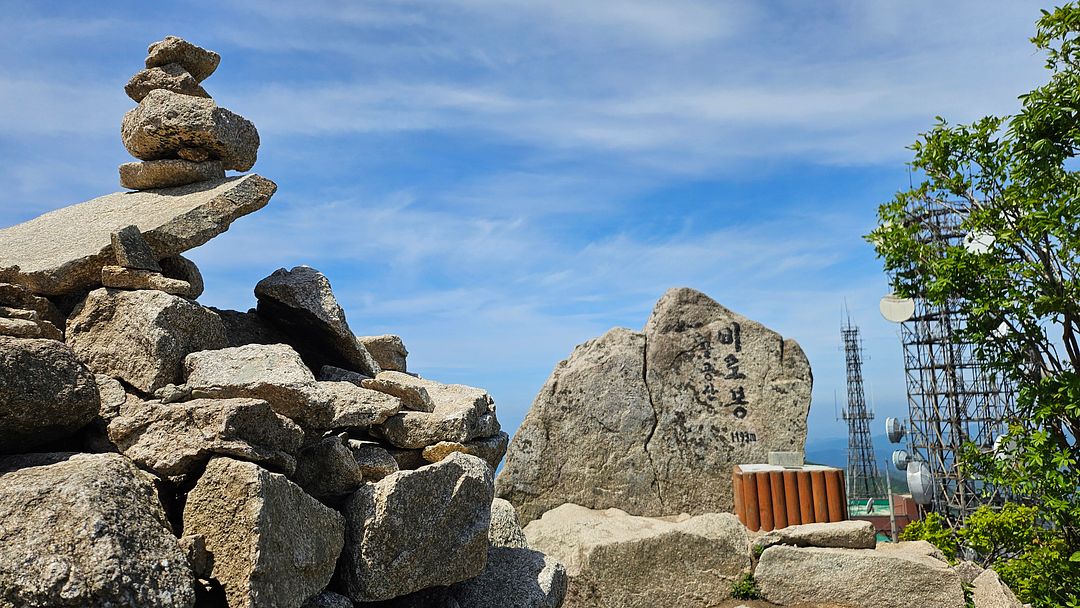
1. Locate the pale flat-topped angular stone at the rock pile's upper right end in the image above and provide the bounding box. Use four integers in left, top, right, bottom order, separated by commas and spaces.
373, 378, 501, 449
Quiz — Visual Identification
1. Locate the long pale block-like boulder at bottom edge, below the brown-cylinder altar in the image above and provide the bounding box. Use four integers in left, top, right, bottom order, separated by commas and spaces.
754, 544, 964, 608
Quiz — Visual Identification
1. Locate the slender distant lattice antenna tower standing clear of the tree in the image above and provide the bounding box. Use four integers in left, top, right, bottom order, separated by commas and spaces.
840, 315, 885, 499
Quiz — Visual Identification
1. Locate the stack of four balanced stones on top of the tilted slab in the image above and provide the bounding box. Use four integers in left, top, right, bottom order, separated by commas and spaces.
120, 36, 259, 190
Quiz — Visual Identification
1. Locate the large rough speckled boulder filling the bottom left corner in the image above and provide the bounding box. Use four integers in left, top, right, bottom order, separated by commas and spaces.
0, 454, 195, 608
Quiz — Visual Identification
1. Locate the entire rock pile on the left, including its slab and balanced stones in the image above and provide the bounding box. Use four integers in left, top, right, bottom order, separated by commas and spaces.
0, 37, 567, 608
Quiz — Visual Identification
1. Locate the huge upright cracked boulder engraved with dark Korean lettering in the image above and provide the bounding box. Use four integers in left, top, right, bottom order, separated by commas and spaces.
498, 288, 811, 522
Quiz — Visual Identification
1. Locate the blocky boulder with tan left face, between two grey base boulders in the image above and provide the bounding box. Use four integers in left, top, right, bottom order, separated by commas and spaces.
184, 458, 343, 608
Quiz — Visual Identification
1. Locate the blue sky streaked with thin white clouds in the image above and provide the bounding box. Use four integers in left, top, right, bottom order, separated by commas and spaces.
0, 0, 1050, 451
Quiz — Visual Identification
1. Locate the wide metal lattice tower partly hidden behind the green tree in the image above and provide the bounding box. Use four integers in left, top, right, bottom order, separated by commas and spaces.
901, 203, 1013, 524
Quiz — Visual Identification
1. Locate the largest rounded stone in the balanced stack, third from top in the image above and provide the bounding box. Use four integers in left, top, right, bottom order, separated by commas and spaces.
120, 89, 259, 171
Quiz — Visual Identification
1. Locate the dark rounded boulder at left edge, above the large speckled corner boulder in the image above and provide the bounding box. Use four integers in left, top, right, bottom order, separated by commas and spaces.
0, 336, 100, 454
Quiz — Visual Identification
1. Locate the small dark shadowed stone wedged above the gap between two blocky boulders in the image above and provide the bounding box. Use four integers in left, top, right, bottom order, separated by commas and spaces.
293, 435, 364, 499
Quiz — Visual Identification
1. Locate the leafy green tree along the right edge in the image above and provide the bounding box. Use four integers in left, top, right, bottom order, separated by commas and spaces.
867, 3, 1080, 607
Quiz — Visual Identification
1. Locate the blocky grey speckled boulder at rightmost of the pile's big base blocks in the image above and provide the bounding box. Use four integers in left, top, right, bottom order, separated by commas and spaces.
338, 454, 494, 602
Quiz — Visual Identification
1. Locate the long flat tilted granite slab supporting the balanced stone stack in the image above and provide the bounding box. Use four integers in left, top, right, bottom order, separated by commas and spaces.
0, 174, 278, 295
